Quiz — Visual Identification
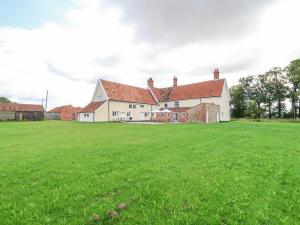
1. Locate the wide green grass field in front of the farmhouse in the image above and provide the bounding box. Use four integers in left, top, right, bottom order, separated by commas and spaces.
0, 121, 300, 225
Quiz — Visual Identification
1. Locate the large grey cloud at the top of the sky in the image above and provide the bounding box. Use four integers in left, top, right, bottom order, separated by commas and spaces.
104, 0, 274, 45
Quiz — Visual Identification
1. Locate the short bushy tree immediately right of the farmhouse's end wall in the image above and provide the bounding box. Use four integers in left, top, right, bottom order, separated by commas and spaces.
229, 84, 247, 118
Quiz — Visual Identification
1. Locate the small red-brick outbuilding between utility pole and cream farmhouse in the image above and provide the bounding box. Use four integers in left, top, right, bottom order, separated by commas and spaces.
46, 105, 81, 120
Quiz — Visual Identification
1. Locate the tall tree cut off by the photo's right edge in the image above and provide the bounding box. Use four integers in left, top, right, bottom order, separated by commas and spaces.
286, 59, 300, 118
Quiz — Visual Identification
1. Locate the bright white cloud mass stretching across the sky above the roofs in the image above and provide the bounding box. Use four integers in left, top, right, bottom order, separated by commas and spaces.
0, 0, 300, 107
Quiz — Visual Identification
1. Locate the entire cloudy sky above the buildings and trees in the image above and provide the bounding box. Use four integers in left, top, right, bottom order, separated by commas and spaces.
0, 0, 300, 109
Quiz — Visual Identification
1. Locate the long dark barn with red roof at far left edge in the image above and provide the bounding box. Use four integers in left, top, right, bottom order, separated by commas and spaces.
0, 102, 44, 121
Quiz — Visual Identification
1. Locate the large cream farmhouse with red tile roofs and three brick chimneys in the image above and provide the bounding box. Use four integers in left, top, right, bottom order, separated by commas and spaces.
78, 69, 230, 123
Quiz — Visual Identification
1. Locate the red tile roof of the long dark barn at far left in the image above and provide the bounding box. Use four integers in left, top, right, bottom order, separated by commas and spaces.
0, 103, 44, 112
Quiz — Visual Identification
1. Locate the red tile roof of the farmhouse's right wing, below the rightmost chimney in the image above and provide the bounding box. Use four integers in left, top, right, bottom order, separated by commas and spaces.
151, 79, 225, 102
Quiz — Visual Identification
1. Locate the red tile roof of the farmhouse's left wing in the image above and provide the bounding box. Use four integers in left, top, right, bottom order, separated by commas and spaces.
100, 80, 156, 105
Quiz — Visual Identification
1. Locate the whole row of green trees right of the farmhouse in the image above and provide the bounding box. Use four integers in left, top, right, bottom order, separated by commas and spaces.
230, 59, 300, 118
